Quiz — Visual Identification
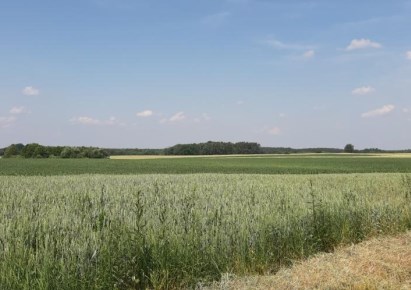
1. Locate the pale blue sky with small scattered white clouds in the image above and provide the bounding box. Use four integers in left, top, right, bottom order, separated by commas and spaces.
0, 0, 411, 149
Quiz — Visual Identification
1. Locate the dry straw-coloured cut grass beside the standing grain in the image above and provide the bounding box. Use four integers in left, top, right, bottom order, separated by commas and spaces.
211, 232, 411, 290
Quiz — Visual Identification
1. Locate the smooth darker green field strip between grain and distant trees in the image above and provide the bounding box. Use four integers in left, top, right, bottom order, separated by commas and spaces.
0, 154, 411, 176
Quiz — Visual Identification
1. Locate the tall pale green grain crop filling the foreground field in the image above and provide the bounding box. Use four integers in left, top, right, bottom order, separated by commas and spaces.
0, 173, 411, 289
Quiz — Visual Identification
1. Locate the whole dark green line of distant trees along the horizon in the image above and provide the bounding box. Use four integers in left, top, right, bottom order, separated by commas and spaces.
0, 141, 411, 158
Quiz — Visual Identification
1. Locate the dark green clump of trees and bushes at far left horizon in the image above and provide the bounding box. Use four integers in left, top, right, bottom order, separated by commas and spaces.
3, 143, 109, 158
